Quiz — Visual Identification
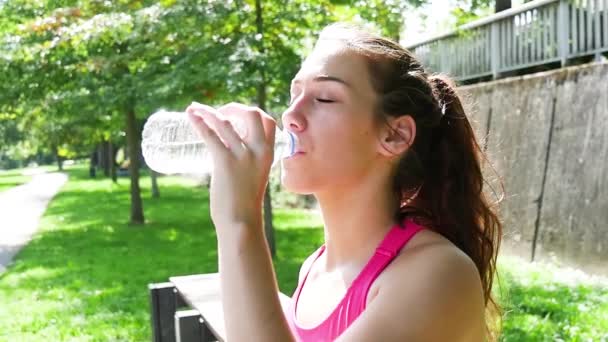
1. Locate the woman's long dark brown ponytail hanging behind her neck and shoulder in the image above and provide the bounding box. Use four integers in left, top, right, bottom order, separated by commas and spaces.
397, 75, 502, 339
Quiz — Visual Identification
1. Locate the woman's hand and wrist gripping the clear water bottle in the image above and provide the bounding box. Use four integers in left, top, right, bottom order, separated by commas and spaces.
186, 102, 276, 236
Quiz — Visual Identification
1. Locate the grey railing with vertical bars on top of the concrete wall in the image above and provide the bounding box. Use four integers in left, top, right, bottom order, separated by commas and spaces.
408, 0, 608, 81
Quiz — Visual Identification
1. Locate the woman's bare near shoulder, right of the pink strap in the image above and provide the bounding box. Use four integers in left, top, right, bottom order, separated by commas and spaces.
354, 230, 485, 341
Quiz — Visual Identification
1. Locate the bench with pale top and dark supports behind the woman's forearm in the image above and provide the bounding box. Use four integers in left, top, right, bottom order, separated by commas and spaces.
148, 273, 291, 342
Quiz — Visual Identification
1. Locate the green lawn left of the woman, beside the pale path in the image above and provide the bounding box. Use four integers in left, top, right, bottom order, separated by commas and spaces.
0, 168, 322, 341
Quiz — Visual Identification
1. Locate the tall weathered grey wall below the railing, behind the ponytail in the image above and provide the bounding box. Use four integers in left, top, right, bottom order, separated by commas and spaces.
459, 63, 608, 274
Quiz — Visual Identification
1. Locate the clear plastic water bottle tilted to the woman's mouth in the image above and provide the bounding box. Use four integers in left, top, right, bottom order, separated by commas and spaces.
141, 110, 297, 175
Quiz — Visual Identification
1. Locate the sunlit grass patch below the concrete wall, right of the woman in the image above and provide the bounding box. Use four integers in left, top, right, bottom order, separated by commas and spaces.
495, 257, 608, 342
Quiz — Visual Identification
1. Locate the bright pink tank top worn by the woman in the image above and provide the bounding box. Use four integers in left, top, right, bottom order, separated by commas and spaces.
286, 219, 424, 342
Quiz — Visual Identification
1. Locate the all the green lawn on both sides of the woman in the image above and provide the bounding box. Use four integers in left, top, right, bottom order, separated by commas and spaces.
0, 167, 608, 341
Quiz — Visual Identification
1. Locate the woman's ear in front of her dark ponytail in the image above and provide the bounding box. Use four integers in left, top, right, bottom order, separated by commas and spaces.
378, 115, 416, 157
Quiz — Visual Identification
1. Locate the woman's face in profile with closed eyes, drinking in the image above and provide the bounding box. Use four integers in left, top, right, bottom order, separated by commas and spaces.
282, 40, 379, 194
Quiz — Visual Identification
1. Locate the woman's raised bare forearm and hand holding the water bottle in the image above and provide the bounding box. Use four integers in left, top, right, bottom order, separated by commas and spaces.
187, 103, 294, 342
